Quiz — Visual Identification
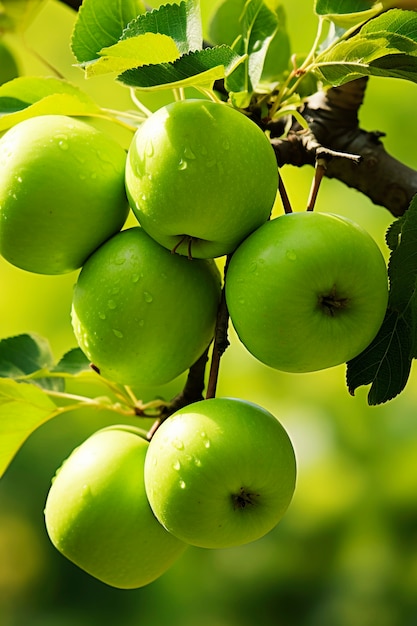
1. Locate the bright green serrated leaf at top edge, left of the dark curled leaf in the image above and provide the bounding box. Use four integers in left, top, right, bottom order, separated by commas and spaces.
71, 0, 145, 63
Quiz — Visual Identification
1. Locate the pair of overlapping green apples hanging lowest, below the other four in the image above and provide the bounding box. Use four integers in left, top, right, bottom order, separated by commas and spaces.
45, 398, 296, 589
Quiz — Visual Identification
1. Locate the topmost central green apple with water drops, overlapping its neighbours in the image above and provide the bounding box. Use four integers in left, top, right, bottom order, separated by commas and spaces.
126, 99, 278, 258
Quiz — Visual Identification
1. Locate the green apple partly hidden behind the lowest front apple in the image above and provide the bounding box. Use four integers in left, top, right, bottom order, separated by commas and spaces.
45, 426, 186, 589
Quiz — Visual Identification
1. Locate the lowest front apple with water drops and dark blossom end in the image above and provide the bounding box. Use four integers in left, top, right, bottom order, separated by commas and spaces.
145, 398, 296, 548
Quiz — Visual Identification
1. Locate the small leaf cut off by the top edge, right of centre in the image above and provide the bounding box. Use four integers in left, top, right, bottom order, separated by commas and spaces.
314, 0, 383, 29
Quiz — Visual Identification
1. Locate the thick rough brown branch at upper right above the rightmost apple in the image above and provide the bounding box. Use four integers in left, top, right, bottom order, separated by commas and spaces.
269, 78, 417, 216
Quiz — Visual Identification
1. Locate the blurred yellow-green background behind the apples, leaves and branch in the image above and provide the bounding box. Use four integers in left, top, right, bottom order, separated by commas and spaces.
0, 0, 417, 626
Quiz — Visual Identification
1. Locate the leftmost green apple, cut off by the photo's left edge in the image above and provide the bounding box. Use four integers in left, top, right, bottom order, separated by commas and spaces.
0, 115, 129, 274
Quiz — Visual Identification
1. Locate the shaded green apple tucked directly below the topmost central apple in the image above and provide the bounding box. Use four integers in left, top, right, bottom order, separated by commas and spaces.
72, 226, 221, 386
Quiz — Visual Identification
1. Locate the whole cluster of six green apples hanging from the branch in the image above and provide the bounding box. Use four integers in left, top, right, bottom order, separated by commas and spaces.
0, 99, 388, 588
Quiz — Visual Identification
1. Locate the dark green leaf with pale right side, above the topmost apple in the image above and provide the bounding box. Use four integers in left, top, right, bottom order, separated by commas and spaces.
121, 0, 203, 54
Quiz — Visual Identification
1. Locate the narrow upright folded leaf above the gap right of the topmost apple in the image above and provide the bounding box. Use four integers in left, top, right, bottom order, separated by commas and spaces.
226, 0, 278, 107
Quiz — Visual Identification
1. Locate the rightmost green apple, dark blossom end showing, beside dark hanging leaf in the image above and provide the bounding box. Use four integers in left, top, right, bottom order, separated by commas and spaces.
226, 211, 388, 372
